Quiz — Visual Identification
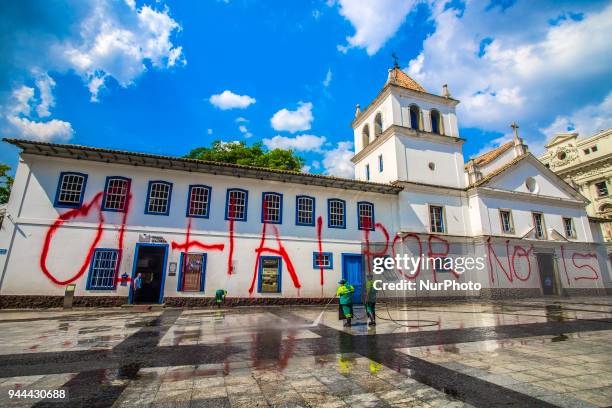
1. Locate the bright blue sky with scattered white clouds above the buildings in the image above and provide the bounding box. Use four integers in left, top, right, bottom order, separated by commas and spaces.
0, 0, 612, 176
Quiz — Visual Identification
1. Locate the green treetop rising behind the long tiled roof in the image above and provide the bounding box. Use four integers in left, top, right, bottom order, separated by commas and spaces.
185, 140, 304, 171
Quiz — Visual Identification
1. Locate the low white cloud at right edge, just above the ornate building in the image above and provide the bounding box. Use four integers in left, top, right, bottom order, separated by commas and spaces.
540, 91, 612, 139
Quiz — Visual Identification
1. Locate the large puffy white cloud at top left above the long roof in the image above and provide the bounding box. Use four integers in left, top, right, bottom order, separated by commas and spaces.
60, 1, 186, 102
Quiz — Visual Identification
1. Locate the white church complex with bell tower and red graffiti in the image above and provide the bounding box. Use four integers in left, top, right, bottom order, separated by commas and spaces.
0, 68, 612, 307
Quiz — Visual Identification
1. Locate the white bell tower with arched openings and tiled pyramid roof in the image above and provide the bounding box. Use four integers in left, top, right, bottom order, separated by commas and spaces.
351, 64, 465, 188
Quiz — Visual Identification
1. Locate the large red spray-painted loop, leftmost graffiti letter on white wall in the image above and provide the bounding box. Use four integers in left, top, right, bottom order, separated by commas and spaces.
40, 192, 104, 285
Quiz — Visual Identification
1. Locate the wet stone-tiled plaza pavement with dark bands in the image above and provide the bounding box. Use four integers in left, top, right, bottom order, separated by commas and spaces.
0, 297, 612, 407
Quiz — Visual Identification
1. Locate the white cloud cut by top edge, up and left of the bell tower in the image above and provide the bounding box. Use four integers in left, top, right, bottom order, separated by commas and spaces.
328, 0, 417, 55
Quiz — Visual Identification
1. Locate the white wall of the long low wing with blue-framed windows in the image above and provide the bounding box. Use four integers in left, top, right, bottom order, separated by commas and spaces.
0, 157, 397, 297
